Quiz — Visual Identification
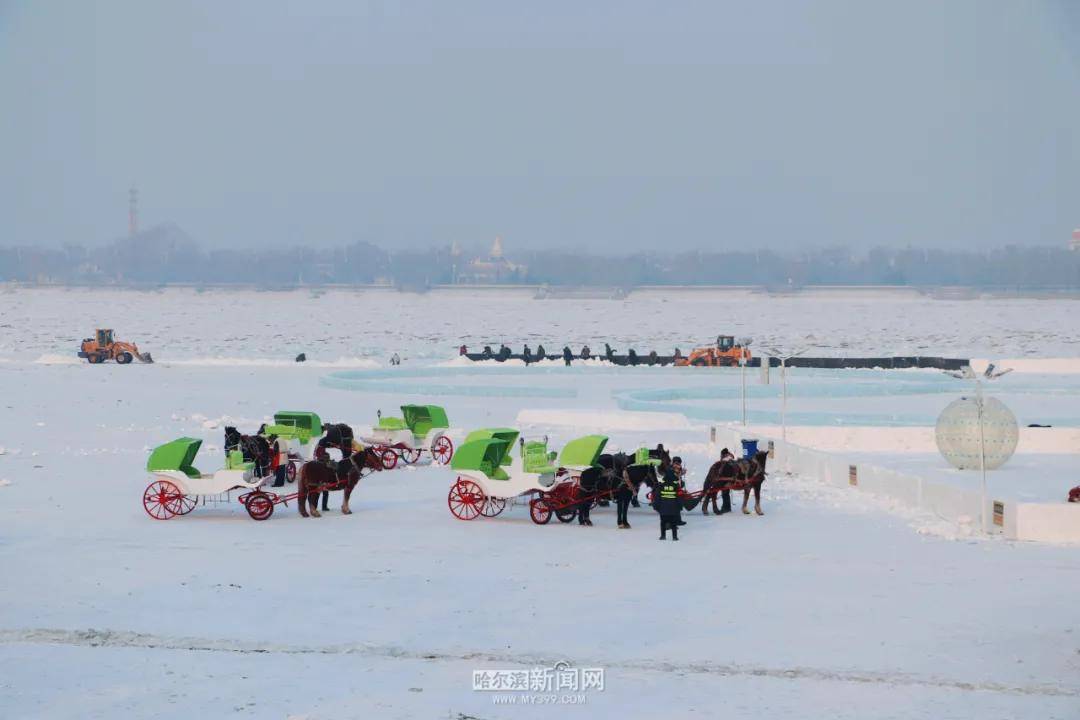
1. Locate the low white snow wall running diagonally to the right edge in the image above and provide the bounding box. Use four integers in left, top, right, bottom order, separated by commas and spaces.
715, 426, 1080, 543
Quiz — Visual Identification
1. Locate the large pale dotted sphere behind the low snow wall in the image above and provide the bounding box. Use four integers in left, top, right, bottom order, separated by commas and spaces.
934, 397, 1020, 470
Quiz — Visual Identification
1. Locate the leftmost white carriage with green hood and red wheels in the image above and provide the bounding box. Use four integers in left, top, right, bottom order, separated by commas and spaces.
143, 437, 272, 520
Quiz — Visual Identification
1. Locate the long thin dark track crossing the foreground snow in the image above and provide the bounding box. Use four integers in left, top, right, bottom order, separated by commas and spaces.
0, 628, 1080, 697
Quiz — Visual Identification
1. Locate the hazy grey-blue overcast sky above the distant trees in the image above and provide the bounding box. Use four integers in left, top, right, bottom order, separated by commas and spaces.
0, 0, 1080, 254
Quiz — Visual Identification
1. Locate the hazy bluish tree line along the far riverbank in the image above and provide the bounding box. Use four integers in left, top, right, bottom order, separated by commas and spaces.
0, 226, 1080, 290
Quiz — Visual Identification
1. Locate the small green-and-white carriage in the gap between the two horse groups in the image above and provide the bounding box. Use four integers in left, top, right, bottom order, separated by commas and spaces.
361, 405, 454, 470
